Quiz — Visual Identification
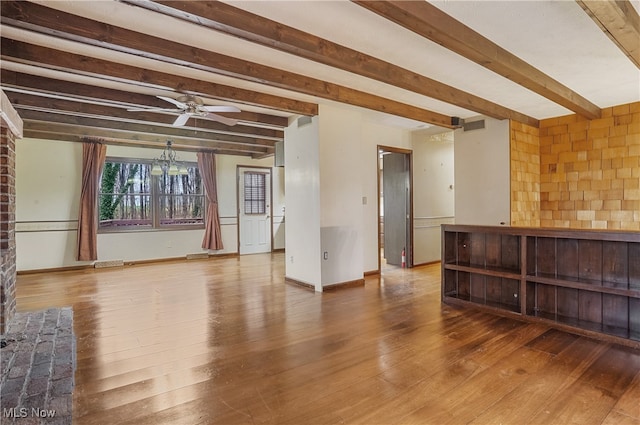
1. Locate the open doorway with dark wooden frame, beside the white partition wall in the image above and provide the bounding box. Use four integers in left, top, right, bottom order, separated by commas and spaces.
378, 146, 413, 270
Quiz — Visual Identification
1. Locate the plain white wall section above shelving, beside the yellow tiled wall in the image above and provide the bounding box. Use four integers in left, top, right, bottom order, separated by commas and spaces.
454, 118, 511, 226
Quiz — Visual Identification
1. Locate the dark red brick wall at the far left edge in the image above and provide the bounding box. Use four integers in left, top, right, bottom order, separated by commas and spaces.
0, 127, 16, 335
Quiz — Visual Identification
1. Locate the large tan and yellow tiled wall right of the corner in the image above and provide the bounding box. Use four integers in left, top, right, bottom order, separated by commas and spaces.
540, 102, 640, 230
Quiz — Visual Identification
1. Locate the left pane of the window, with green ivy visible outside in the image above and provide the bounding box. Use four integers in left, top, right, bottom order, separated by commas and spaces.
98, 161, 152, 228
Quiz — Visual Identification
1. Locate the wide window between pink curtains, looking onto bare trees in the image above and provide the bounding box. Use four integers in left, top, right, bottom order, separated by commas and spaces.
98, 158, 205, 231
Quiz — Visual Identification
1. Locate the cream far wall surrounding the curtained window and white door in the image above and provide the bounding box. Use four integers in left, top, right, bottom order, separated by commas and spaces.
16, 139, 284, 271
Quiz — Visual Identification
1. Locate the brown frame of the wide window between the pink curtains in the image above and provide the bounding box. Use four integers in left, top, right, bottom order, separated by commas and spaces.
96, 157, 208, 234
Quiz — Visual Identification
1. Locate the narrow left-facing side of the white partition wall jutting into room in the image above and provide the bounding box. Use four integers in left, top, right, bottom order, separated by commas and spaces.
284, 116, 322, 291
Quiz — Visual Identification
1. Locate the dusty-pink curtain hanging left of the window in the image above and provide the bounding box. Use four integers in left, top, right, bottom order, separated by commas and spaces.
78, 141, 107, 261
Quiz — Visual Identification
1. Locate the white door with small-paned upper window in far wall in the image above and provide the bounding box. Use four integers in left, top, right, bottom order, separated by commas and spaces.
238, 167, 272, 255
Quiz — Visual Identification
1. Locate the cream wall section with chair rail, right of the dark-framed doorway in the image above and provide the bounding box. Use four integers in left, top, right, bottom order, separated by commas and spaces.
412, 131, 455, 265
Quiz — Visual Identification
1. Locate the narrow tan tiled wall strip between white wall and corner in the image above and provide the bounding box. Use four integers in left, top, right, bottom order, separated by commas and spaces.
510, 121, 540, 227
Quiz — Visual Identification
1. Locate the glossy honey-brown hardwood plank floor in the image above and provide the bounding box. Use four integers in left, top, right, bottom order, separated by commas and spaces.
17, 254, 640, 424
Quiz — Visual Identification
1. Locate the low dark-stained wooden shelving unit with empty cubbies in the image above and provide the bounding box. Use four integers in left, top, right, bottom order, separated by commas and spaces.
442, 225, 640, 346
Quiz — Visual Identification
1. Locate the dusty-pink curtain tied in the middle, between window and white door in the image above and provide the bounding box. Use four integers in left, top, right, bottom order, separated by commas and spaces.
198, 152, 222, 250
